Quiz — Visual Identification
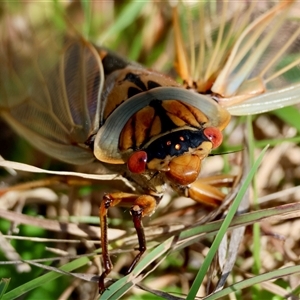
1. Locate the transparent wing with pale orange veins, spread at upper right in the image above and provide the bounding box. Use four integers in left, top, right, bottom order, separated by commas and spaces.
174, 1, 300, 115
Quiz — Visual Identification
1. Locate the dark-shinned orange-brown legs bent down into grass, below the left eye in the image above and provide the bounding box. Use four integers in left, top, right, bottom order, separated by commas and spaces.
99, 193, 159, 294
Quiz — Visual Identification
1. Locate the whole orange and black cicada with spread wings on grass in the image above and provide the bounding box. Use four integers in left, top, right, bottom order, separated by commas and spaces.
0, 1, 300, 293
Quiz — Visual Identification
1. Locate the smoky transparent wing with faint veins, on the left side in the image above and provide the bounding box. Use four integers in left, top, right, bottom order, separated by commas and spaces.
0, 2, 104, 164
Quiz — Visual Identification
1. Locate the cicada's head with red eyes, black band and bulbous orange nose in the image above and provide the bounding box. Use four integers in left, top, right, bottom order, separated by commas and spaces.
127, 127, 222, 185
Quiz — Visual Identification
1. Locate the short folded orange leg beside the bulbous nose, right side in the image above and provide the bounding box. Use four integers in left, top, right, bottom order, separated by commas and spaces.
177, 175, 236, 207
